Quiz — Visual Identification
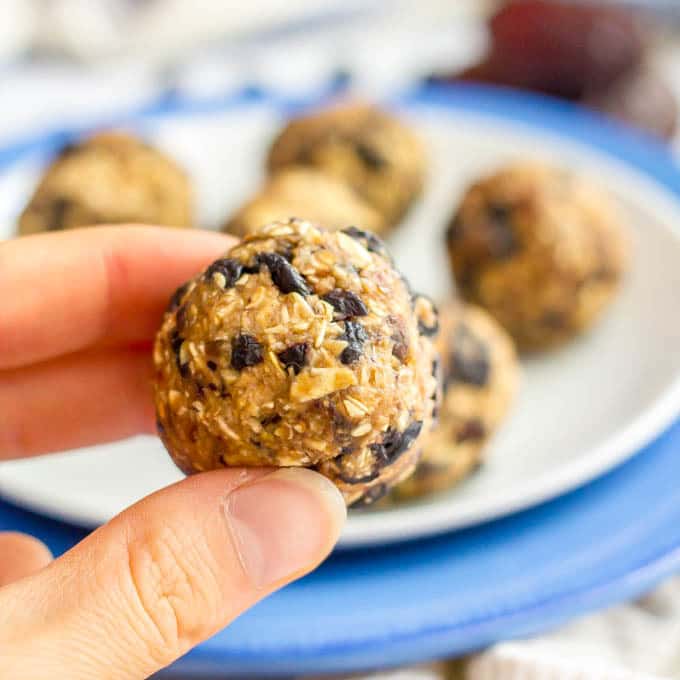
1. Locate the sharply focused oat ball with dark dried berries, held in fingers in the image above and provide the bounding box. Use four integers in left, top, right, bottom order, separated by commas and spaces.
154, 219, 437, 504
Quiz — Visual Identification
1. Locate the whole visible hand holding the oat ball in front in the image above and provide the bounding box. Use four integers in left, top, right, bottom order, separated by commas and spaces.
0, 226, 345, 680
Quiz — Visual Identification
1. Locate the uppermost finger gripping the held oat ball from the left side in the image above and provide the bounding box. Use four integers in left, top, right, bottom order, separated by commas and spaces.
0, 226, 234, 369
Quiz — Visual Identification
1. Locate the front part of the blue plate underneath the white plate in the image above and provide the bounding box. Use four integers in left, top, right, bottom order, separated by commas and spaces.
0, 424, 680, 680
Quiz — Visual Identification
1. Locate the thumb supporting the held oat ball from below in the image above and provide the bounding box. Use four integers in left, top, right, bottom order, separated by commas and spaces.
0, 468, 346, 680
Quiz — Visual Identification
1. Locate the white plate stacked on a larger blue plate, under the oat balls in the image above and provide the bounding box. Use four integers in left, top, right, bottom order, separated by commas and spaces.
0, 87, 680, 677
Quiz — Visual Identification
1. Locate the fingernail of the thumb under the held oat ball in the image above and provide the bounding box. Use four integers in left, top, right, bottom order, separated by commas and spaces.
225, 468, 347, 588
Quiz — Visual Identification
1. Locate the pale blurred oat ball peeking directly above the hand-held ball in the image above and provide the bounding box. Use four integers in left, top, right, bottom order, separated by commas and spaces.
224, 166, 385, 236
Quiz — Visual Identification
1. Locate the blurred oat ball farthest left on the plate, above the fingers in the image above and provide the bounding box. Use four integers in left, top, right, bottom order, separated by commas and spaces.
19, 132, 192, 234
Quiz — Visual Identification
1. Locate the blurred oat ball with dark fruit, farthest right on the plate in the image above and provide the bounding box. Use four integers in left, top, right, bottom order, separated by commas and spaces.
447, 163, 628, 350
